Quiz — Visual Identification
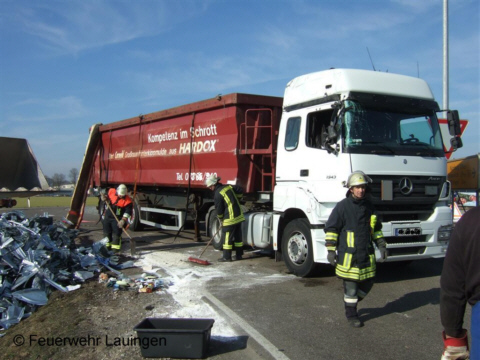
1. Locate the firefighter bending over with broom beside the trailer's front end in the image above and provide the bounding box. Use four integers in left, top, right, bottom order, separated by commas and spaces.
205, 174, 245, 262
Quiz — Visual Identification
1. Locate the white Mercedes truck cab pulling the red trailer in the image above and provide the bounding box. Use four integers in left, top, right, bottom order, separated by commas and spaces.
273, 69, 461, 276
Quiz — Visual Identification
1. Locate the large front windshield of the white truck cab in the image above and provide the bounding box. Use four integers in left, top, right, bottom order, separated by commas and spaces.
341, 100, 444, 157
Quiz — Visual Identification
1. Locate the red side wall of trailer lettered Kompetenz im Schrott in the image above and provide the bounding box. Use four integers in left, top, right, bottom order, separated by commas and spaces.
92, 94, 282, 192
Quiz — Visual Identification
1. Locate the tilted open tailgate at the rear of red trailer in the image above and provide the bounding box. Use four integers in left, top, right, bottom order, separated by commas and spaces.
67, 124, 102, 229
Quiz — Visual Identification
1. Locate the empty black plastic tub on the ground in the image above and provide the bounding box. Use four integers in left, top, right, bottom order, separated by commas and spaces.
133, 318, 215, 359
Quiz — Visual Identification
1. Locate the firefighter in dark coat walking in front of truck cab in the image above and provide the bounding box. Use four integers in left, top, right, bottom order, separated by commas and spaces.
325, 171, 387, 327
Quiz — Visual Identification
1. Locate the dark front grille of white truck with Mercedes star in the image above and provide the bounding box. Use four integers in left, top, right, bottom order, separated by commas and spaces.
370, 175, 446, 222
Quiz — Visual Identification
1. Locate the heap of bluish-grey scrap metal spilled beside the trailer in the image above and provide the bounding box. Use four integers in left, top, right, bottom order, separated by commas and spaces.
0, 211, 133, 336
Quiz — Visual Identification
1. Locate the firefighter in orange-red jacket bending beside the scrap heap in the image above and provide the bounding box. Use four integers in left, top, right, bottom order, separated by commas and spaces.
100, 184, 133, 253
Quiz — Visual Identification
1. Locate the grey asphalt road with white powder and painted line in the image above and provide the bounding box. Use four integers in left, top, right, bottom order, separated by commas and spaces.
9, 208, 470, 360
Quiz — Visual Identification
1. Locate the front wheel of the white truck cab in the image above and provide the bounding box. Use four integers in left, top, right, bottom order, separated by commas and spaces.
282, 219, 315, 277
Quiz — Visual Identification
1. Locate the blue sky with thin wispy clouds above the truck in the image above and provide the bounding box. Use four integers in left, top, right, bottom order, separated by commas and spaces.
0, 0, 480, 177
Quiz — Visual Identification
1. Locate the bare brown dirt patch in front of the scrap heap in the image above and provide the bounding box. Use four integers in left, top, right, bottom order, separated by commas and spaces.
0, 266, 171, 359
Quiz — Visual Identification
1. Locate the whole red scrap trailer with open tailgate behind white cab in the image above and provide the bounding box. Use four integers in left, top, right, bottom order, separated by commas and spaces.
68, 93, 283, 240
